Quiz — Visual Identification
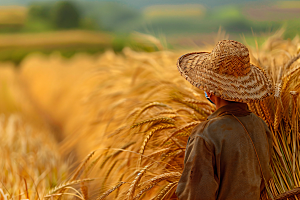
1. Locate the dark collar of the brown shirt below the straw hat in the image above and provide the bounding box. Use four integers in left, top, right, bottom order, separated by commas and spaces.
207, 102, 251, 119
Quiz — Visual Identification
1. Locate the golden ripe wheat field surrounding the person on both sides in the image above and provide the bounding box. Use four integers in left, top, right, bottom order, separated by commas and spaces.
0, 32, 300, 200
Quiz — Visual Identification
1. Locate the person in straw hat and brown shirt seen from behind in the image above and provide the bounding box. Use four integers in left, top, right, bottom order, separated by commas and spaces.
176, 40, 273, 200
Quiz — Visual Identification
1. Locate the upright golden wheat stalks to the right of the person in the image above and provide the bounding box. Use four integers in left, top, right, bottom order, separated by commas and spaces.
249, 35, 300, 199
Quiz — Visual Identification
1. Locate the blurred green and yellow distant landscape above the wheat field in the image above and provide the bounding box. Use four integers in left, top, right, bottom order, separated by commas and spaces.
0, 0, 300, 64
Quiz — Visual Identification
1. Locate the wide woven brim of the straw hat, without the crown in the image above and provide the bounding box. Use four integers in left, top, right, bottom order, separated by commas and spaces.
177, 52, 273, 103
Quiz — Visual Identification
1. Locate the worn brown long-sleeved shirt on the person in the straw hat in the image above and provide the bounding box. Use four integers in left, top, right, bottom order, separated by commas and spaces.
176, 103, 272, 200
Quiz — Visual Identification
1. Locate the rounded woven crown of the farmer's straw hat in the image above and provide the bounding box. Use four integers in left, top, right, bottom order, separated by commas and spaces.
211, 40, 251, 77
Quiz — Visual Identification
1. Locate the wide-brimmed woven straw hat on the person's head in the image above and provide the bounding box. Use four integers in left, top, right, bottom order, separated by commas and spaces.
177, 40, 273, 103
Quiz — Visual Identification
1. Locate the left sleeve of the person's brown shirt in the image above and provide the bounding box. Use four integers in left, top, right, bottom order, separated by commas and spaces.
176, 136, 219, 200
